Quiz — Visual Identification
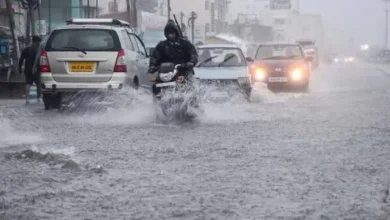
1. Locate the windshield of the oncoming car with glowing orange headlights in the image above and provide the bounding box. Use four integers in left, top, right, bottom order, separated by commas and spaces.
256, 45, 303, 60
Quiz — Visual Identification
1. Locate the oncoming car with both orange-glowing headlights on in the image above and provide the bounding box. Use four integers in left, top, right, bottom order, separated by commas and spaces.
251, 43, 313, 91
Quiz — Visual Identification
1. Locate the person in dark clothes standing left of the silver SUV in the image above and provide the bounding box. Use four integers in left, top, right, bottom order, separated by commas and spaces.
19, 36, 41, 104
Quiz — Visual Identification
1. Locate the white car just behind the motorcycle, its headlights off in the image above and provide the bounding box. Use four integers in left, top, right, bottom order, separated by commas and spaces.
195, 45, 252, 98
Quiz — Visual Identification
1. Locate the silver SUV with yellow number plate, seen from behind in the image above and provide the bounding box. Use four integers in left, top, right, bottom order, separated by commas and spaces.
40, 19, 149, 109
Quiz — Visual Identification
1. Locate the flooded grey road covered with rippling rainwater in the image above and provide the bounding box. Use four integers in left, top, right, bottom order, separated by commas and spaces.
0, 64, 390, 220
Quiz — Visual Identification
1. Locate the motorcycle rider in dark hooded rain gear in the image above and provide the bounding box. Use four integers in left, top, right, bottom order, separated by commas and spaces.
148, 20, 198, 95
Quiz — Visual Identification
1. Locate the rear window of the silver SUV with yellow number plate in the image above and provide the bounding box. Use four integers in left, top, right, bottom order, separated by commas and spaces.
46, 29, 121, 51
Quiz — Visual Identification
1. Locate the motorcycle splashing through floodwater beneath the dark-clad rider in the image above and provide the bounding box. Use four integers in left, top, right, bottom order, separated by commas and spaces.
152, 63, 197, 122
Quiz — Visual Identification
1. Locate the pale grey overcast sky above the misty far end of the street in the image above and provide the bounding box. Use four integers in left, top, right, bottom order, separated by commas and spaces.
301, 0, 390, 45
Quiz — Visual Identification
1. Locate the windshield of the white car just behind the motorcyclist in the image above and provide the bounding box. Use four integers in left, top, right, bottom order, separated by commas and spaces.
198, 47, 246, 67
